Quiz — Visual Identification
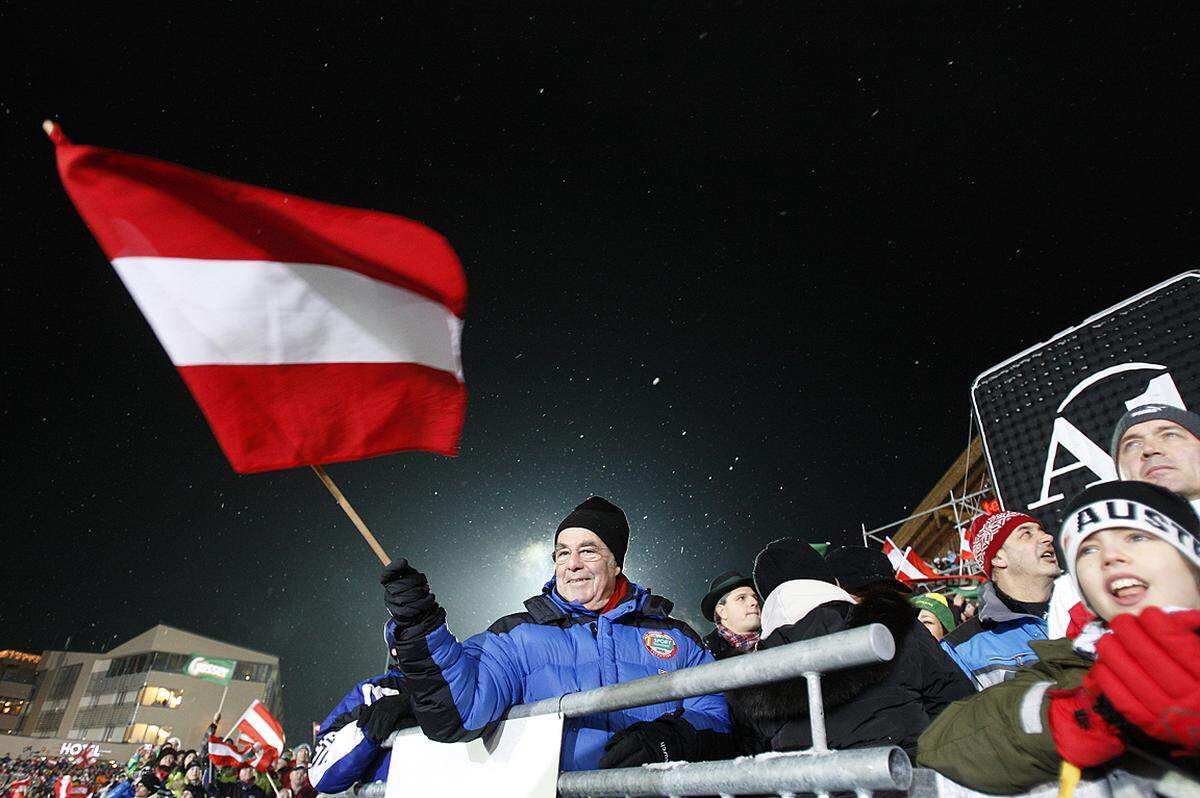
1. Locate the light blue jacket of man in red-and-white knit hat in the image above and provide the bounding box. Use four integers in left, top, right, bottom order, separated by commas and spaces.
942, 582, 1046, 690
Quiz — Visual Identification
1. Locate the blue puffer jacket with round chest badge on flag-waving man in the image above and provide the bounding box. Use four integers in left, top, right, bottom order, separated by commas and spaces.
396, 580, 730, 770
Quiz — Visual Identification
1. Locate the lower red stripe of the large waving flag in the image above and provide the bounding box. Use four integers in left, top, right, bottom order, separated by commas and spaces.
179, 362, 467, 474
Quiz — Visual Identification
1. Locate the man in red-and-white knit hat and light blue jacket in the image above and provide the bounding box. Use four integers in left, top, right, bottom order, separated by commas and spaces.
942, 511, 1060, 690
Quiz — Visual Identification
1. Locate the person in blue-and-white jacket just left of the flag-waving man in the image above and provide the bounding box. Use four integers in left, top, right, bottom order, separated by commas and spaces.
309, 620, 416, 793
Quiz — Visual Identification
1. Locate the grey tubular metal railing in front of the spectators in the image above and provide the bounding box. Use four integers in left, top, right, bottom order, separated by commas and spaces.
321, 624, 912, 798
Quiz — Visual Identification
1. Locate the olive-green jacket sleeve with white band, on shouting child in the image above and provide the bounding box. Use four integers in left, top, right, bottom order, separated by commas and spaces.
917, 665, 1060, 793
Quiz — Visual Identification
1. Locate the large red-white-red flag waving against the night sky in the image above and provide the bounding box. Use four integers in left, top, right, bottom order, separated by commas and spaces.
49, 126, 467, 473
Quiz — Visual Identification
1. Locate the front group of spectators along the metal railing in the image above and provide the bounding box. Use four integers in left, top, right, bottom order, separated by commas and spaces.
304, 406, 1200, 792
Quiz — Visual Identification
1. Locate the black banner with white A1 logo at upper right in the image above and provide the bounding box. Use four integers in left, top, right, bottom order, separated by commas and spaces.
971, 271, 1200, 529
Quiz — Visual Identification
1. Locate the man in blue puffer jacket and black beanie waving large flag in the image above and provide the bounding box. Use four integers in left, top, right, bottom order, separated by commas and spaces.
380, 497, 731, 770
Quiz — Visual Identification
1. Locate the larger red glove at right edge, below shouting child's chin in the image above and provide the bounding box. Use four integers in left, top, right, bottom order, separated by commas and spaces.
1084, 607, 1200, 754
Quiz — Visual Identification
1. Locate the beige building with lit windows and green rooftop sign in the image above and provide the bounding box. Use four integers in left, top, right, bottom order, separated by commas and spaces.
15, 625, 283, 748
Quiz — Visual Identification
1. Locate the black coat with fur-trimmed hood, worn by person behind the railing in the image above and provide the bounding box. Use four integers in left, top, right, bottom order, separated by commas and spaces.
726, 588, 917, 726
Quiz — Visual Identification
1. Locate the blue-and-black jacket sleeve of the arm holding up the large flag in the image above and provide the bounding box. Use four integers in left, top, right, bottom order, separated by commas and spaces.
396, 624, 524, 743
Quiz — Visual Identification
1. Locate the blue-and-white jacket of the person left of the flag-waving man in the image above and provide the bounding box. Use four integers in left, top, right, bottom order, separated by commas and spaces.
308, 668, 404, 793
